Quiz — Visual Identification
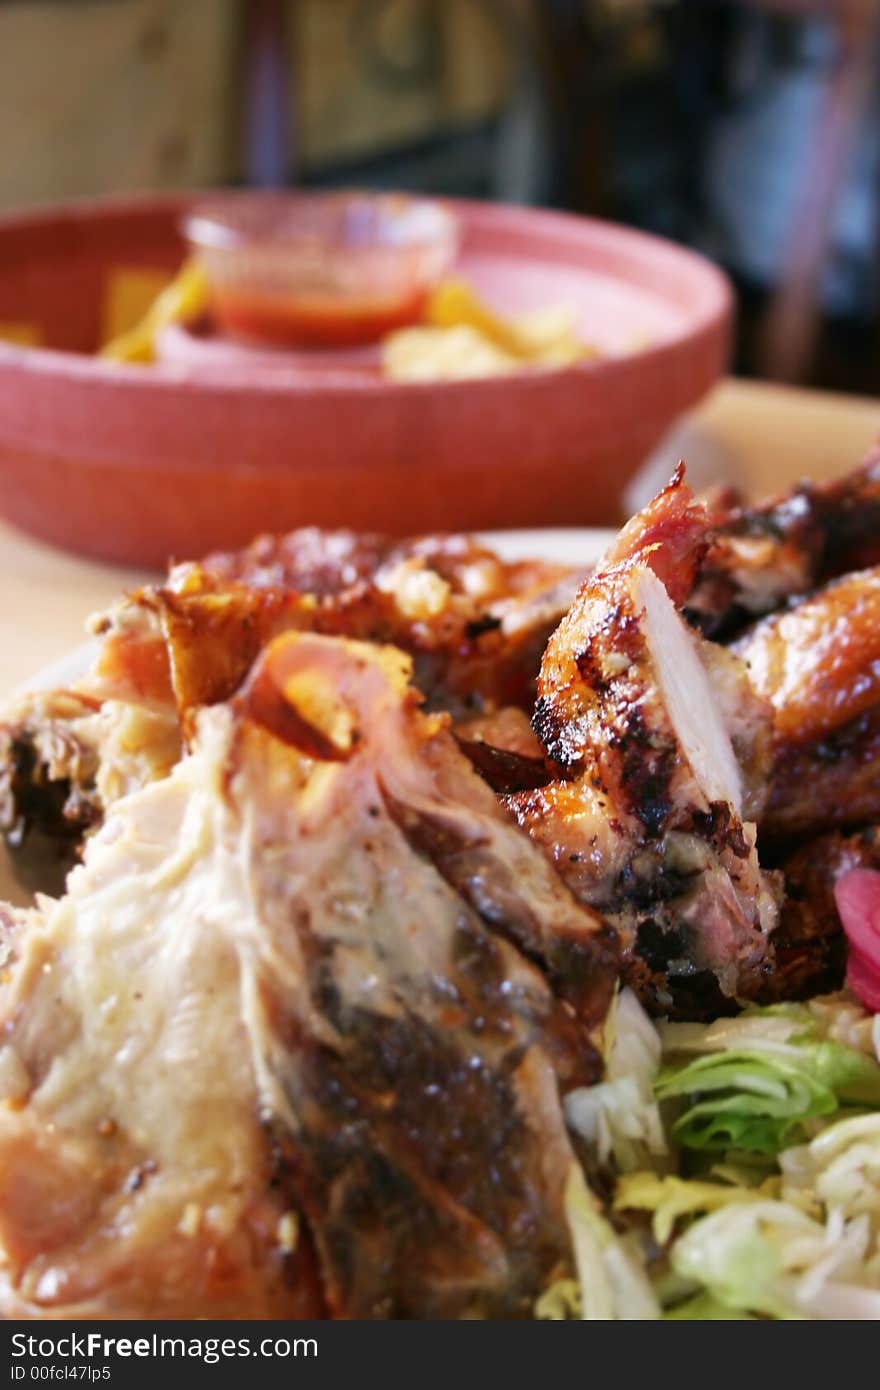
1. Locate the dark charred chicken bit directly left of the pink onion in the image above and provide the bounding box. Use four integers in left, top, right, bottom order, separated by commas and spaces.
753, 826, 880, 1004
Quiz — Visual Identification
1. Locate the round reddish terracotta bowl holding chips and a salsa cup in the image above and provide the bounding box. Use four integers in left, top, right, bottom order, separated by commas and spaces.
0, 196, 731, 564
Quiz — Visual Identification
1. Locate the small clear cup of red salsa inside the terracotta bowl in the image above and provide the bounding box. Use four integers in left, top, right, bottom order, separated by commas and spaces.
184, 192, 459, 348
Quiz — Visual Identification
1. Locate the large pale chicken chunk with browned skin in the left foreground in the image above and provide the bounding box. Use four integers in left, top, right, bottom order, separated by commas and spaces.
0, 634, 617, 1318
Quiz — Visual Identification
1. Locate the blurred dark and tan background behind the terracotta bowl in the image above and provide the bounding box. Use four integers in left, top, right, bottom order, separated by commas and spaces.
0, 0, 880, 393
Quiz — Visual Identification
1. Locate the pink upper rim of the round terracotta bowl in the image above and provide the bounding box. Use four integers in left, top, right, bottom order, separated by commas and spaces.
0, 189, 734, 399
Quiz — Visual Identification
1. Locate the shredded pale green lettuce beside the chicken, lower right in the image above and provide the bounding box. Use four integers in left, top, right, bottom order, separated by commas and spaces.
550, 991, 880, 1321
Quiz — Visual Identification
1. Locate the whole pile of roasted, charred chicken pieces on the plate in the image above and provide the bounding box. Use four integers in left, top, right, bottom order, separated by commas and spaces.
0, 461, 880, 1318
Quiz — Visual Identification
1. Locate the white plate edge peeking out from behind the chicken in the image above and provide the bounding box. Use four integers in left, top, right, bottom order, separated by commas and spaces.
0, 527, 614, 904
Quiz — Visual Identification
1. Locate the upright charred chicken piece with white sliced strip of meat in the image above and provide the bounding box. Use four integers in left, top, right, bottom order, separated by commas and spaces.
509, 480, 779, 1012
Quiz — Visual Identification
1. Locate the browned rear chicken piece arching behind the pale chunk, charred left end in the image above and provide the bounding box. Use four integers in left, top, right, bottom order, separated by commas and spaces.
0, 528, 586, 892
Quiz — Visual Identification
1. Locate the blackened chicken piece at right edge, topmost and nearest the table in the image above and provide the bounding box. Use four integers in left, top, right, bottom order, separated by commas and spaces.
685, 455, 880, 637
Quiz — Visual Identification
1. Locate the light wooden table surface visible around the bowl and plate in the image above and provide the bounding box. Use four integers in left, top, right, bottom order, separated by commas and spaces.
0, 379, 880, 694
